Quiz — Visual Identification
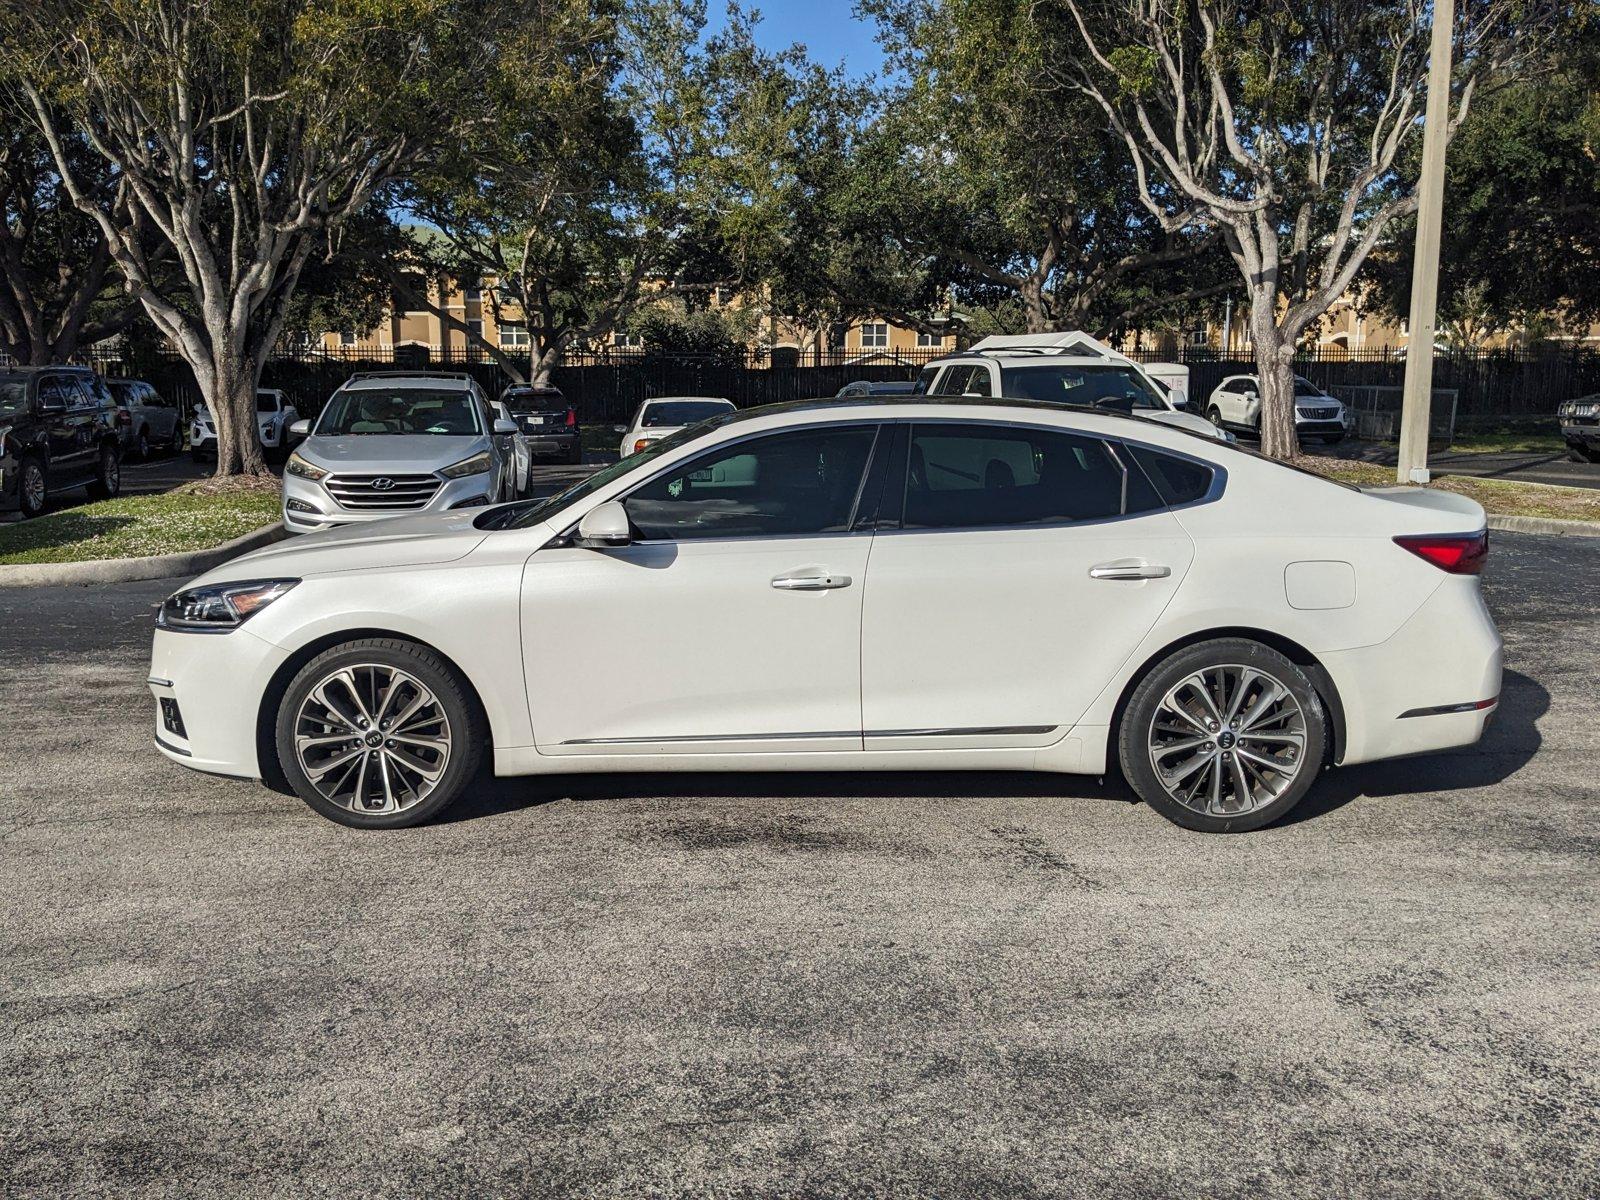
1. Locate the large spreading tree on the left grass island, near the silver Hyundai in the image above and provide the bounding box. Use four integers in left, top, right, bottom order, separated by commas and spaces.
0, 0, 565, 475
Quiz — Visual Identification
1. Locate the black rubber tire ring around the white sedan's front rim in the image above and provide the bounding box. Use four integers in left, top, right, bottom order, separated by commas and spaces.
275, 637, 488, 829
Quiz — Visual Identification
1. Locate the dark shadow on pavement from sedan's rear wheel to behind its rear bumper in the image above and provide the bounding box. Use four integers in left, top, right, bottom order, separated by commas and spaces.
1277, 670, 1550, 826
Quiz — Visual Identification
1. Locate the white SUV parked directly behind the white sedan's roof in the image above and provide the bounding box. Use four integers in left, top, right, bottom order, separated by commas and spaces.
915, 331, 1229, 440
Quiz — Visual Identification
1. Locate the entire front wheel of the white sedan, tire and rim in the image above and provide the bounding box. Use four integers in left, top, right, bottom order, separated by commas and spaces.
277, 638, 486, 829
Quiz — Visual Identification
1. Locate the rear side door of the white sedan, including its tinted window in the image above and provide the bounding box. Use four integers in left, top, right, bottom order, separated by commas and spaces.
861, 421, 1194, 750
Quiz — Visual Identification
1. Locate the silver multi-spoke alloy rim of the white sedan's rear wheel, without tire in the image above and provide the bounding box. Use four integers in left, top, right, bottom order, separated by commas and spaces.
1147, 666, 1306, 816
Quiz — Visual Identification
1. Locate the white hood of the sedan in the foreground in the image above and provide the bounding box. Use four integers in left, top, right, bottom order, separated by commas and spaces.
197, 509, 488, 584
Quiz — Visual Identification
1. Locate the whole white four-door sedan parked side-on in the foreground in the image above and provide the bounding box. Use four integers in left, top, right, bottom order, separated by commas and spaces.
150, 400, 1501, 830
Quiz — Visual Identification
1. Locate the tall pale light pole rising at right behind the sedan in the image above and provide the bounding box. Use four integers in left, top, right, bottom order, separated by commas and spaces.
1395, 0, 1456, 483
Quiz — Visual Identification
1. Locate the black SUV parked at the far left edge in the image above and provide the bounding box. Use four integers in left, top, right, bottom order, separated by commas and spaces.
0, 366, 122, 517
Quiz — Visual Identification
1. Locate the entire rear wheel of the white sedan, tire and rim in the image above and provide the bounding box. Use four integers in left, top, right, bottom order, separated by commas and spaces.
1117, 638, 1328, 834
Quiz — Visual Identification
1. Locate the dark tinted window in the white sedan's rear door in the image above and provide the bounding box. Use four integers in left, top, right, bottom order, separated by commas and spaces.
904, 426, 1138, 530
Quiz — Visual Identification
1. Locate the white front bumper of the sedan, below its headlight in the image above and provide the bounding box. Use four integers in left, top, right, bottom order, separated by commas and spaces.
149, 629, 288, 779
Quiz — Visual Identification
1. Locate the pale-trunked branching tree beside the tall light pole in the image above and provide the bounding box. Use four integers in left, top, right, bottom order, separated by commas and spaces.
1050, 0, 1534, 458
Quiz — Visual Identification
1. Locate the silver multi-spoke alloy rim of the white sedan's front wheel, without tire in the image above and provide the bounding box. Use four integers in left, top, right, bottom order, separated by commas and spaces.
294, 662, 453, 816
